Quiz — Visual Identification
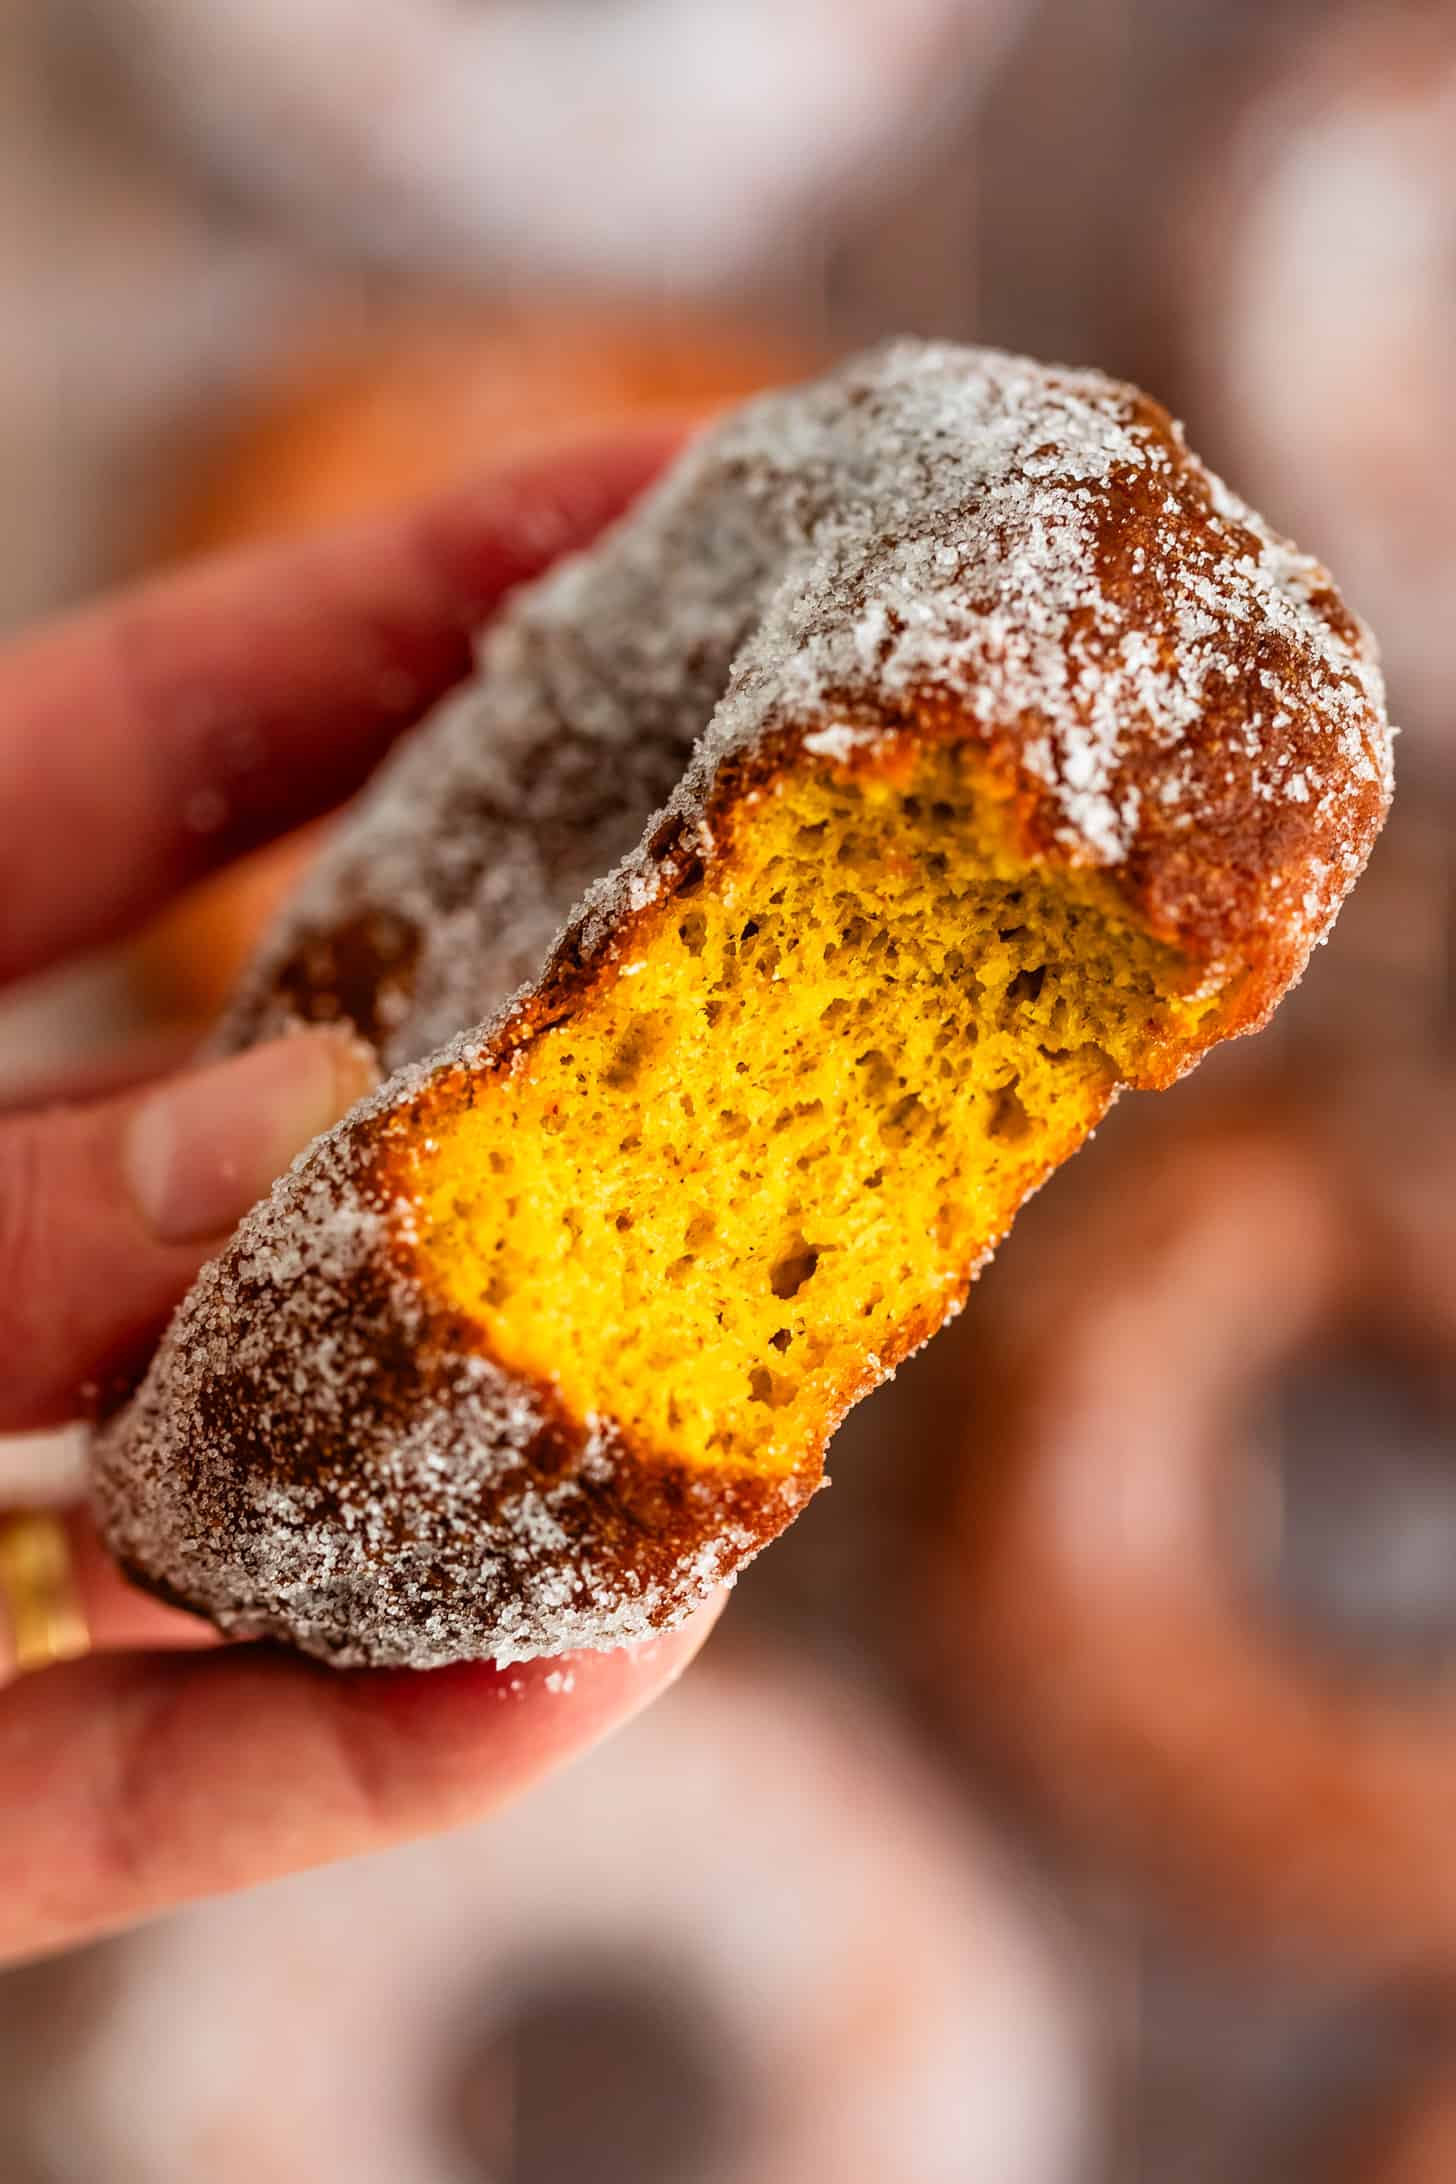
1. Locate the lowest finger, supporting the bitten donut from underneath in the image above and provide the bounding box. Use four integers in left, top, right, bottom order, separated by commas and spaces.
0, 1601, 723, 1959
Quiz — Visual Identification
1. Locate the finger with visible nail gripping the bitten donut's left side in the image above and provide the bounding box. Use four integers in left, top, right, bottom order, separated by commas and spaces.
0, 1035, 373, 1433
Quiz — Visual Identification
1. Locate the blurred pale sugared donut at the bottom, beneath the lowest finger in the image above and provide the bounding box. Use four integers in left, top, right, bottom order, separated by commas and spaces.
0, 1655, 1096, 2184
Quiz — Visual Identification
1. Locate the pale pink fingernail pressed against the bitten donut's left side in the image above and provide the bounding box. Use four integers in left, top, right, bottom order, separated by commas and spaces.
122, 1035, 375, 1243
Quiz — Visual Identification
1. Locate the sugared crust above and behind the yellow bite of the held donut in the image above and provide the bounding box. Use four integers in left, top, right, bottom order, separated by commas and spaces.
234, 343, 1391, 1066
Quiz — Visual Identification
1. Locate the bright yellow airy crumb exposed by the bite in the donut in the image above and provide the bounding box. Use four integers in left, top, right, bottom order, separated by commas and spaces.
406, 747, 1222, 1474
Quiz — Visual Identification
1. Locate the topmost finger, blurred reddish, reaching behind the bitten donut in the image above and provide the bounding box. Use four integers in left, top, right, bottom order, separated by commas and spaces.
0, 428, 681, 978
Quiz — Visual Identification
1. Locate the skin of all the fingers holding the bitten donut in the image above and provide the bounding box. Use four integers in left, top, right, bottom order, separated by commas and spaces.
0, 432, 720, 1961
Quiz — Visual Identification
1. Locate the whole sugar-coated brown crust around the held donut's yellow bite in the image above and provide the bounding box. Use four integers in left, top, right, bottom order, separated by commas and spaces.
98, 343, 1391, 1666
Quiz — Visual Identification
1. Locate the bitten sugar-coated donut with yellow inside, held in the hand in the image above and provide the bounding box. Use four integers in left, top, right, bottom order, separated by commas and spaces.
96, 343, 1391, 1666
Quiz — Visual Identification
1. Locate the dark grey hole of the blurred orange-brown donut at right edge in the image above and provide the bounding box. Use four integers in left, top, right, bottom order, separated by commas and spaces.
1244, 1348, 1456, 1682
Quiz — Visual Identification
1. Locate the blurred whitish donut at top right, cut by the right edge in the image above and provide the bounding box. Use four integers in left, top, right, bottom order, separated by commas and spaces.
1179, 0, 1456, 767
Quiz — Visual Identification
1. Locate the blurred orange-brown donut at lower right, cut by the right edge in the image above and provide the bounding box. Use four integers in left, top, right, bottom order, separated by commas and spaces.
941, 1064, 1456, 1979
